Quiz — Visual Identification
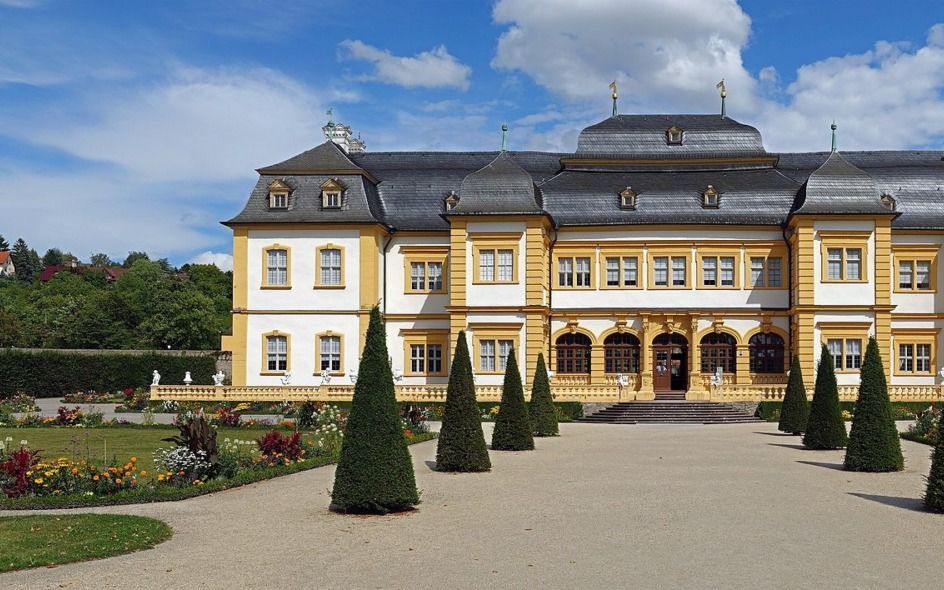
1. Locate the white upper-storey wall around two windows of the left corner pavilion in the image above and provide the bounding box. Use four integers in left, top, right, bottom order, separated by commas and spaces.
247, 229, 362, 310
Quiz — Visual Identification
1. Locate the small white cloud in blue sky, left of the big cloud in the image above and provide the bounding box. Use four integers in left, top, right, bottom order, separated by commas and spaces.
338, 39, 472, 90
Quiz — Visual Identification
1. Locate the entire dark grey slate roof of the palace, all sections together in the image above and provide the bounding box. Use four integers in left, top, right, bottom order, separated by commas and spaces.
227, 115, 944, 230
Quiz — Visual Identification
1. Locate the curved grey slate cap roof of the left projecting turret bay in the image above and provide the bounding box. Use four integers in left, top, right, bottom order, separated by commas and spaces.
449, 152, 544, 215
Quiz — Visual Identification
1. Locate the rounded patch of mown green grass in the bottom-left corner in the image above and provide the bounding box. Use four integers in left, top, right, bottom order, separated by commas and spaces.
0, 514, 173, 572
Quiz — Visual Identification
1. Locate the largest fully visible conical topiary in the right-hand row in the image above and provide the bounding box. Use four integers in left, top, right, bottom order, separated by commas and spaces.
844, 338, 905, 472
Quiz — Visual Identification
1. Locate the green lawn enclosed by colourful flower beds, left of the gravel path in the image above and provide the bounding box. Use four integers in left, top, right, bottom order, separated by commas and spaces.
0, 426, 280, 472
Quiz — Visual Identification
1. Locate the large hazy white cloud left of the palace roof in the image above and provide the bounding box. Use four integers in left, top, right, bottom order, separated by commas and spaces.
0, 67, 324, 182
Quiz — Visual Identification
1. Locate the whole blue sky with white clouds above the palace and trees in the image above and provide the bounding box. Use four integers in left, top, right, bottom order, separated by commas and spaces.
0, 0, 944, 267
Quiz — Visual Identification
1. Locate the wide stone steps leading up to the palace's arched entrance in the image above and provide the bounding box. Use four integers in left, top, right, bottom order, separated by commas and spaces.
577, 400, 763, 424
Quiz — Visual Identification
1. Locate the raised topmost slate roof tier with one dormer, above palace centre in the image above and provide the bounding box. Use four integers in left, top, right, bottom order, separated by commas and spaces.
574, 115, 767, 159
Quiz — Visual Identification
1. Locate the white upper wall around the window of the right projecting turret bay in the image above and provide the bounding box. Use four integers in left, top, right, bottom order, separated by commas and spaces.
813, 221, 875, 305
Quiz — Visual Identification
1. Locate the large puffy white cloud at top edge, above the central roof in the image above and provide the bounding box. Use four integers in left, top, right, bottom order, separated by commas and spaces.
492, 0, 755, 112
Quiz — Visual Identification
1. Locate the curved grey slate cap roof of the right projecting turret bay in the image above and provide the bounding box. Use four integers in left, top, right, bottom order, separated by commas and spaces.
793, 152, 889, 215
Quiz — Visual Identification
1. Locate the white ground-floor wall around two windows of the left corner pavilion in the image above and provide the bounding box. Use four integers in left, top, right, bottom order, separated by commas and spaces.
246, 314, 360, 385
